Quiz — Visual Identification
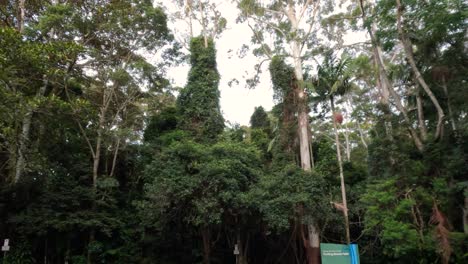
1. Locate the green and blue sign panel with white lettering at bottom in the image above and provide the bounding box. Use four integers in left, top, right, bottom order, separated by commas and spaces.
320, 243, 359, 264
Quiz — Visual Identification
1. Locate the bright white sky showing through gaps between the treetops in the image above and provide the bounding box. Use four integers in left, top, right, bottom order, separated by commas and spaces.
165, 1, 365, 125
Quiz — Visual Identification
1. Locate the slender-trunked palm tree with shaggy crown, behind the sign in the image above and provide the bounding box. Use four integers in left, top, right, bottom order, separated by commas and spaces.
314, 52, 352, 244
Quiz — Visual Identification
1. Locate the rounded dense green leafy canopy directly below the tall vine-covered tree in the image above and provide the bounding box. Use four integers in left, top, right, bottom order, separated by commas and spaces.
143, 138, 261, 226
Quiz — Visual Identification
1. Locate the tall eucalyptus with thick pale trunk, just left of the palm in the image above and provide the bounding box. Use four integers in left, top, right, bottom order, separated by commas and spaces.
238, 0, 326, 263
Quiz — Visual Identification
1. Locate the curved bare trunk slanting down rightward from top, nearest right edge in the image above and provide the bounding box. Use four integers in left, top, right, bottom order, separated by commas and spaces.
396, 0, 444, 139
